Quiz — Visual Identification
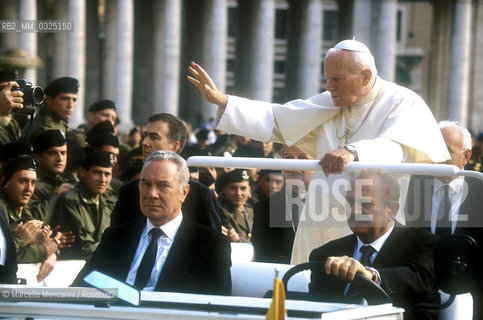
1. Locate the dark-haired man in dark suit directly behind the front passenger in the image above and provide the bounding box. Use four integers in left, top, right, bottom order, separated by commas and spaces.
111, 113, 221, 232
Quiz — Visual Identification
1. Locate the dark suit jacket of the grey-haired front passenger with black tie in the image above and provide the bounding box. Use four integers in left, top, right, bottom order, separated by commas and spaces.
72, 218, 231, 295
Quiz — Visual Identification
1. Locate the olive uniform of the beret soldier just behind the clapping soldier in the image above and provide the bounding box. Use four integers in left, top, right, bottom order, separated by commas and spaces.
28, 169, 79, 224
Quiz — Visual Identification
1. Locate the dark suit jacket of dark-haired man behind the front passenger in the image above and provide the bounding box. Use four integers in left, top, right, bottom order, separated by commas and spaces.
111, 179, 221, 232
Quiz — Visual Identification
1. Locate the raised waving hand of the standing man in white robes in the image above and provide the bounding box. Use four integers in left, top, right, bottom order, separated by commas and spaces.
187, 62, 228, 108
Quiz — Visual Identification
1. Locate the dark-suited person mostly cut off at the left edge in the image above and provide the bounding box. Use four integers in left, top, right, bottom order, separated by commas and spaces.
0, 206, 17, 284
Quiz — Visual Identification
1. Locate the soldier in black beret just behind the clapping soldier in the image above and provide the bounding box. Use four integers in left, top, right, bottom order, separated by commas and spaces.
29, 130, 79, 223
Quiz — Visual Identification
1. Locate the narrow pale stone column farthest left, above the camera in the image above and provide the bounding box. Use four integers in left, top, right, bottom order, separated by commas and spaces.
18, 0, 37, 84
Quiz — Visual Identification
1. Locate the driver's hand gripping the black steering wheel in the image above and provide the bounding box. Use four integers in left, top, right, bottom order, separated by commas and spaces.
325, 256, 372, 281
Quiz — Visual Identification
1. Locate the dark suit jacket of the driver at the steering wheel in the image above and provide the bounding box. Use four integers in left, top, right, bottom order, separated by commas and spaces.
309, 224, 440, 319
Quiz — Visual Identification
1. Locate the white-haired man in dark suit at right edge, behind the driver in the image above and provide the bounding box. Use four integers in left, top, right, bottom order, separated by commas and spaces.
405, 121, 483, 319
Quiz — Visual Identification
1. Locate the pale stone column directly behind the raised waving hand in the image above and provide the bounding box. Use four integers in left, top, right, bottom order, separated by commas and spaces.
200, 0, 228, 121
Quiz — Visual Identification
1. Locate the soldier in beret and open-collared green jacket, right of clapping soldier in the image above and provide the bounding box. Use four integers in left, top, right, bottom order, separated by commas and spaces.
54, 151, 115, 260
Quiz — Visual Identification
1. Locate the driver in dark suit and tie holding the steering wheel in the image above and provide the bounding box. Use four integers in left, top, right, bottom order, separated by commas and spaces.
309, 169, 439, 319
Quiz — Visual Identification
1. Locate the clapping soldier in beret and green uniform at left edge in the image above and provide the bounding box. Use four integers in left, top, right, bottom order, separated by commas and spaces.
0, 155, 63, 281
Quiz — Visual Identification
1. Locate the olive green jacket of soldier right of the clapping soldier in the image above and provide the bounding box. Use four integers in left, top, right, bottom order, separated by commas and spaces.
54, 181, 115, 260
